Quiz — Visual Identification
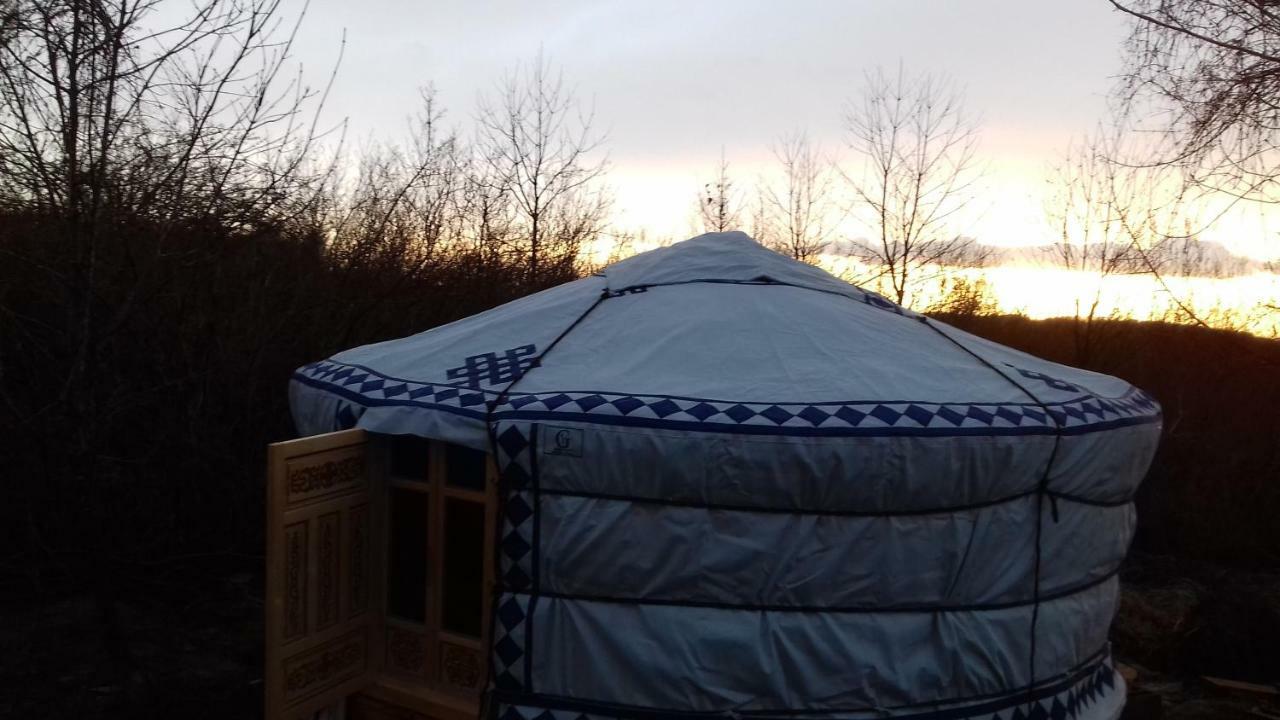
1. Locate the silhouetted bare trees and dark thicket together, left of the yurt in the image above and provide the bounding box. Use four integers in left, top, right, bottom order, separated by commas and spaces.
0, 0, 596, 609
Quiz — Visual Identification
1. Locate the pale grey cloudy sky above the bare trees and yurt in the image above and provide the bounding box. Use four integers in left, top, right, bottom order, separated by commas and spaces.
296, 0, 1263, 254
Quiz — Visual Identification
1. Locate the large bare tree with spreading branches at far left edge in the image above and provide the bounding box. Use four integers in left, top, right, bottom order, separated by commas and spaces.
0, 0, 337, 652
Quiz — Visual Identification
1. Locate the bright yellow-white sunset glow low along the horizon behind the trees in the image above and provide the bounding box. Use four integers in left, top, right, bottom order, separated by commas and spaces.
589, 149, 1280, 337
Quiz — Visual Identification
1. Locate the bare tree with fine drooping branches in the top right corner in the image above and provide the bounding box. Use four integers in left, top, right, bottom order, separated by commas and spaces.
1110, 0, 1280, 325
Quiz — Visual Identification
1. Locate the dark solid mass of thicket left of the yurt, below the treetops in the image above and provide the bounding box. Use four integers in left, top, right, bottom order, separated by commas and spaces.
0, 202, 573, 571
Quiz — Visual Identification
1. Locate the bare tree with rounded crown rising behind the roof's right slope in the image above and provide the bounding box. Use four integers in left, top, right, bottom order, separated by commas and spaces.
844, 68, 987, 304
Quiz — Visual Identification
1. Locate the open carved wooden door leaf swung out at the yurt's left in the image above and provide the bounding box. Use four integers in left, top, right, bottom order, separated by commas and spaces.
264, 430, 383, 720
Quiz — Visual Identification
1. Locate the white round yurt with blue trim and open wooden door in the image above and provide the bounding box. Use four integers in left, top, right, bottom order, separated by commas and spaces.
268, 232, 1161, 720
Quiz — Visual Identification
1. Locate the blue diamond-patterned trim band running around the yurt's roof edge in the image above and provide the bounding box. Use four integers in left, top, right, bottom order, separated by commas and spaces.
293, 360, 1161, 436
